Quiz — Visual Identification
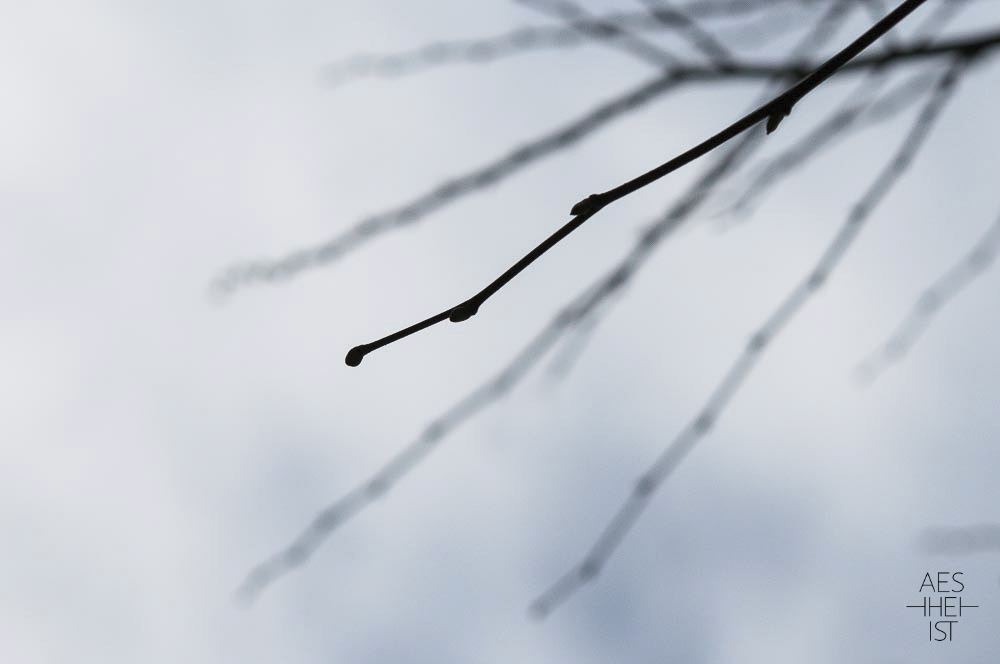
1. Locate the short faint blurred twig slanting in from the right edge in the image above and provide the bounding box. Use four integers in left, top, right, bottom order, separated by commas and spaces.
857, 208, 1000, 384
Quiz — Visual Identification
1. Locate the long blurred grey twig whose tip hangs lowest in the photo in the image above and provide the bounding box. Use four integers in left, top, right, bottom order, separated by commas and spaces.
531, 58, 968, 617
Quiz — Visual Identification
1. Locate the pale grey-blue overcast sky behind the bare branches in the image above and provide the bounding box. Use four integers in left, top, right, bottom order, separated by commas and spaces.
0, 0, 1000, 664
